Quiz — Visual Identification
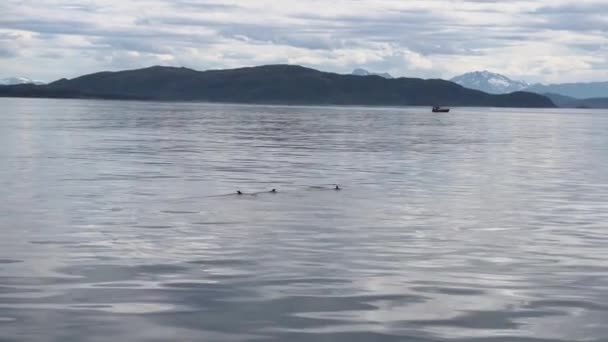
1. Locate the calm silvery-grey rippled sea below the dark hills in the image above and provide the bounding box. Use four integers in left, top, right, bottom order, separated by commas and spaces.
0, 99, 608, 342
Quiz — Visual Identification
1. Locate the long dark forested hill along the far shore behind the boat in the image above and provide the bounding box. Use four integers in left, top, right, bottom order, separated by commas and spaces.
0, 65, 554, 107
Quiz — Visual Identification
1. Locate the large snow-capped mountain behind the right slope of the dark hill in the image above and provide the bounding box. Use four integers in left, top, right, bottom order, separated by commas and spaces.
450, 71, 530, 94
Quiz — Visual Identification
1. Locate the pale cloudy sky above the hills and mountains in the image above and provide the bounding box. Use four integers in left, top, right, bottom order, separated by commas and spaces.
0, 0, 608, 83
